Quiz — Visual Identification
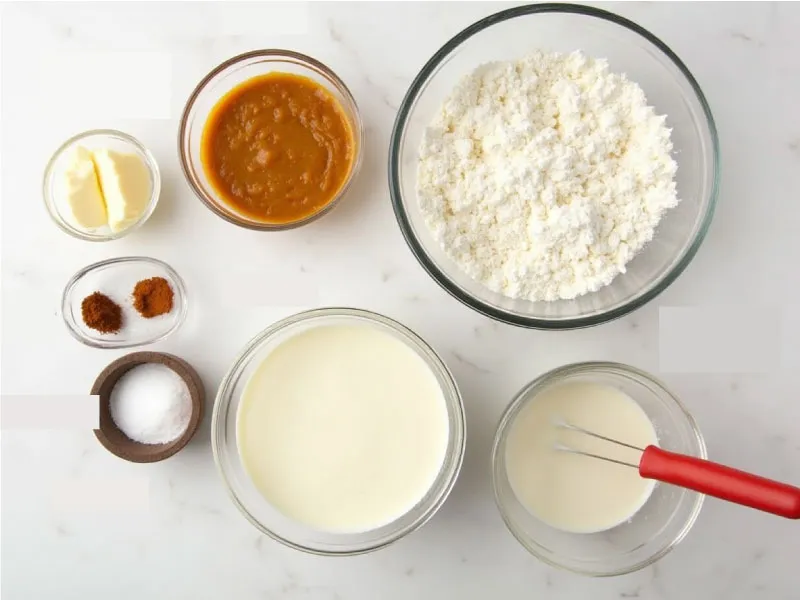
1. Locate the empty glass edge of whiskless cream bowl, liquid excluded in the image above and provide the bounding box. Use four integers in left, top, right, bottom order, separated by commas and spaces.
211, 308, 466, 556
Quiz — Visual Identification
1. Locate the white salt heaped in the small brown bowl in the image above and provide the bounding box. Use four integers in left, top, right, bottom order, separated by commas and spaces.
109, 363, 192, 444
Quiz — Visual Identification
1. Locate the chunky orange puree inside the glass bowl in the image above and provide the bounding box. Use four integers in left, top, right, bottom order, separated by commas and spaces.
200, 73, 355, 224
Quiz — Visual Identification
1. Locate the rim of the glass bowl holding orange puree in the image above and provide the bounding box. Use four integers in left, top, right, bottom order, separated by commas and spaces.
178, 48, 366, 231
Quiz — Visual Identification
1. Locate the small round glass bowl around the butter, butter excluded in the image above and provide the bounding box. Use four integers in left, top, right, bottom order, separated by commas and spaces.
43, 129, 161, 242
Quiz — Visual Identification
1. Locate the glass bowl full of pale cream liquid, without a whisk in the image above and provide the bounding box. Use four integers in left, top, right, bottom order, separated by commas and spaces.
212, 308, 466, 555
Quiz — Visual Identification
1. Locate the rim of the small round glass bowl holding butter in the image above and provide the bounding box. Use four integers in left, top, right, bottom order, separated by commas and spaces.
42, 129, 161, 242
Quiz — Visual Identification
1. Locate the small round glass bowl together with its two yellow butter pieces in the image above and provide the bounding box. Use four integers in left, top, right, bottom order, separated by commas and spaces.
43, 129, 161, 242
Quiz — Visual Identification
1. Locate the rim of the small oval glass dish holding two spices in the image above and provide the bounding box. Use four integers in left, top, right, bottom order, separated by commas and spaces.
61, 256, 189, 350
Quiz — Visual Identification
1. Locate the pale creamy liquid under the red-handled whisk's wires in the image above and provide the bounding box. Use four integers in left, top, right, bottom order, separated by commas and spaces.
506, 382, 657, 533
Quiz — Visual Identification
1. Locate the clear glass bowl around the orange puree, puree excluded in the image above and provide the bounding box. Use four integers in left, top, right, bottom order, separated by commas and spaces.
178, 50, 364, 231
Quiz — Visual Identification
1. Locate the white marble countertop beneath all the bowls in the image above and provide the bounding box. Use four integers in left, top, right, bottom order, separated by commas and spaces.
2, 2, 800, 600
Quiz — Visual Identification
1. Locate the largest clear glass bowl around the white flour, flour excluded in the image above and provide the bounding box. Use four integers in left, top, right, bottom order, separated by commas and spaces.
389, 4, 719, 329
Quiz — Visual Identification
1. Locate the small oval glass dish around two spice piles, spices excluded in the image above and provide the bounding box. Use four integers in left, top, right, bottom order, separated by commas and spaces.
61, 256, 189, 348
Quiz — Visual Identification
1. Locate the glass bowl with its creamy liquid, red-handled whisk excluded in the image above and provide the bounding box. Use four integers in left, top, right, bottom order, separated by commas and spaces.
492, 362, 706, 577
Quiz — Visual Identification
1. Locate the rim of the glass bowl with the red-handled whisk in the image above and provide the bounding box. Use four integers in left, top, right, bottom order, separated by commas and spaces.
491, 361, 708, 577
